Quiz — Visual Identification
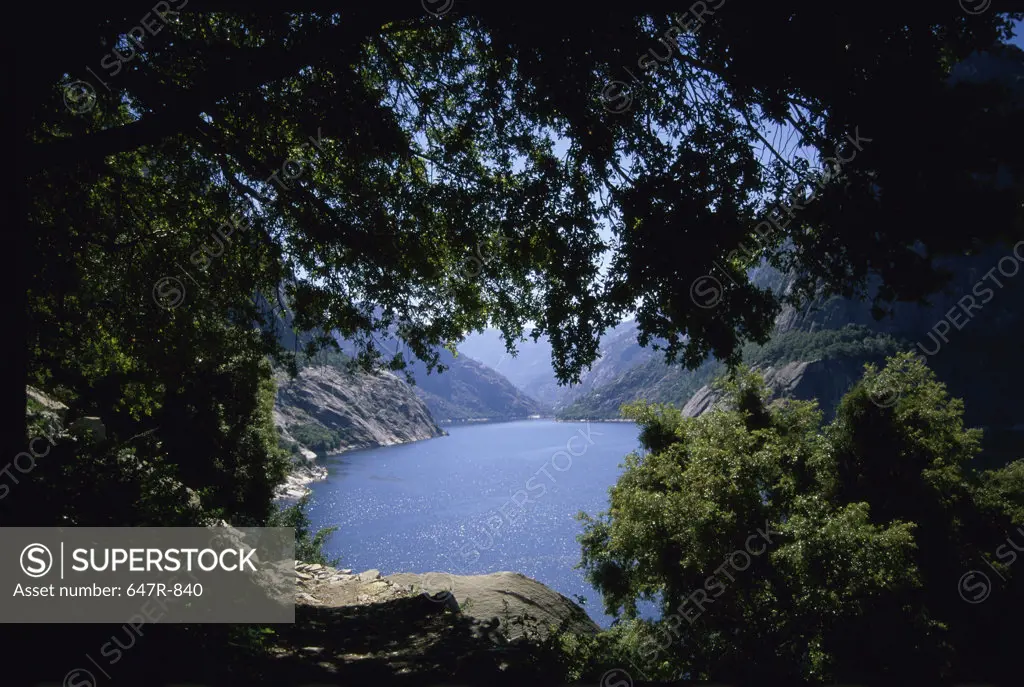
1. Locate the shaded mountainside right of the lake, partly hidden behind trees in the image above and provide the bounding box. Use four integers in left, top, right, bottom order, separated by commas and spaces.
559, 244, 1024, 460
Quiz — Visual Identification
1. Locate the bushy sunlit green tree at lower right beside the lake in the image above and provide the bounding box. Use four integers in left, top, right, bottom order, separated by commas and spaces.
581, 354, 1024, 683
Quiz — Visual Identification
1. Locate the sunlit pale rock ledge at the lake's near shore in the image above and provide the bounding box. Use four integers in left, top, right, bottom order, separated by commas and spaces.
296, 563, 600, 639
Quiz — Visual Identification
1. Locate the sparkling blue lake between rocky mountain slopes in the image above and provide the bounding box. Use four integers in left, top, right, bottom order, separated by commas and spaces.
310, 420, 639, 627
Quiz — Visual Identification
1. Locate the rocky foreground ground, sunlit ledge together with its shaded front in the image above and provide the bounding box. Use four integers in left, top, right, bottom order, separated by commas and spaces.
249, 563, 597, 687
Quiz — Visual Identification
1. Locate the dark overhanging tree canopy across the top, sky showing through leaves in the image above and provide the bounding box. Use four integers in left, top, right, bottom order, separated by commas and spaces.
4, 0, 1021, 473
